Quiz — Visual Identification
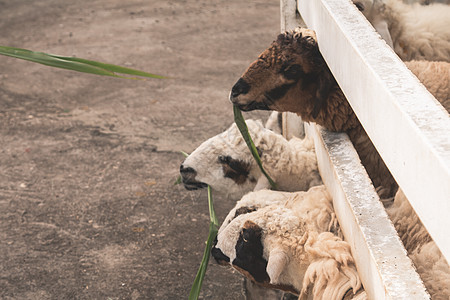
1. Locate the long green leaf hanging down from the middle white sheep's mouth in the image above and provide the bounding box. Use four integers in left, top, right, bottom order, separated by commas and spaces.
188, 186, 219, 300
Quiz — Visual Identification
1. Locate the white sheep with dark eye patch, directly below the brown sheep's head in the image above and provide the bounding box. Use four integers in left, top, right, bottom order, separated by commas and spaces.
180, 120, 322, 199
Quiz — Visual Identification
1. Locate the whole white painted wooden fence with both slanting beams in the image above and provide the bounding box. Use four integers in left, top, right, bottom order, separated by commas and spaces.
281, 0, 450, 300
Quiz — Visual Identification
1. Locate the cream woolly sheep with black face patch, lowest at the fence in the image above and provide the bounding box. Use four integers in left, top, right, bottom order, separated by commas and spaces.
211, 185, 365, 299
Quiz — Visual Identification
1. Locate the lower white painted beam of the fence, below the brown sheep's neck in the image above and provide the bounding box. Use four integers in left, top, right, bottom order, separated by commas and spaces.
305, 124, 429, 300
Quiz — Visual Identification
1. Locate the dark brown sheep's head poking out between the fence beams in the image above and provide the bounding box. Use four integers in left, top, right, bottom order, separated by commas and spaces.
230, 28, 336, 121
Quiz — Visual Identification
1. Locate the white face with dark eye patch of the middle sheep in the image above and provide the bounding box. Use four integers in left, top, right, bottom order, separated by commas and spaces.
180, 120, 263, 199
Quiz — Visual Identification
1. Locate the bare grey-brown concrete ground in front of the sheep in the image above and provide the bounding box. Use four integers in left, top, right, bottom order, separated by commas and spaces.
0, 0, 279, 300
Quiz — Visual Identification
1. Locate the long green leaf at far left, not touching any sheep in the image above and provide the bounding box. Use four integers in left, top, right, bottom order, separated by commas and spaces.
0, 46, 166, 79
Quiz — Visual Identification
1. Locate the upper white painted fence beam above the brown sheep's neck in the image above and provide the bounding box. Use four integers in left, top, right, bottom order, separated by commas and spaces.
298, 0, 450, 261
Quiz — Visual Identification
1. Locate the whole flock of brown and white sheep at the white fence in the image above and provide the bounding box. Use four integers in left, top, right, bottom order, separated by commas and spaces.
180, 0, 450, 300
